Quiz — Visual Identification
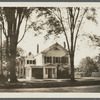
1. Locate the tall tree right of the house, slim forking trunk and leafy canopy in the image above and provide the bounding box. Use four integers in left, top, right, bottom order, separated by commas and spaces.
33, 7, 96, 81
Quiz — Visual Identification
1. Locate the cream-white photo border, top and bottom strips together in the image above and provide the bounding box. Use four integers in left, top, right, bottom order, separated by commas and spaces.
0, 2, 100, 98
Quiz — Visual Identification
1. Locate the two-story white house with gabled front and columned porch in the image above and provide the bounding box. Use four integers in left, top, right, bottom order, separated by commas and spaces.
25, 43, 70, 79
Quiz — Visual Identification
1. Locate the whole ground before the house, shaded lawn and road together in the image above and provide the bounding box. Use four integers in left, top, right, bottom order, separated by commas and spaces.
0, 77, 100, 93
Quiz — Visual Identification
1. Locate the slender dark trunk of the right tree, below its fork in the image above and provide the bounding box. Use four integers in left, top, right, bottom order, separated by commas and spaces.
70, 53, 75, 81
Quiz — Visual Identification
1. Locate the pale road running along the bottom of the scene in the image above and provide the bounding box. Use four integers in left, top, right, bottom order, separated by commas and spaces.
0, 85, 100, 93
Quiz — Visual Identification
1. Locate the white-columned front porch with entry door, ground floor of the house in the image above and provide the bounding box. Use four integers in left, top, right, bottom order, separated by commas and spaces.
25, 65, 57, 80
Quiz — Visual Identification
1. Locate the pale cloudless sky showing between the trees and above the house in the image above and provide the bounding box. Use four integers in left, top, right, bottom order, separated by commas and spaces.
3, 7, 100, 66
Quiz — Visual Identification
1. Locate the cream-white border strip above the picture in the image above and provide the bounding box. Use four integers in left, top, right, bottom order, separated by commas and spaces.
0, 2, 100, 7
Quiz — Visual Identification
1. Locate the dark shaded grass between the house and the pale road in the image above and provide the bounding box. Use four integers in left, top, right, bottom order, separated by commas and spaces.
0, 80, 100, 89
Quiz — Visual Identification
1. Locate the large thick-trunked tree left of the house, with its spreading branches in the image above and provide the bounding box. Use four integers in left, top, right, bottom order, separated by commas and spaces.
0, 7, 33, 82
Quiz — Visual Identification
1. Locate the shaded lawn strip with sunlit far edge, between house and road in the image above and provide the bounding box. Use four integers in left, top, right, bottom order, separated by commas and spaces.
0, 78, 100, 89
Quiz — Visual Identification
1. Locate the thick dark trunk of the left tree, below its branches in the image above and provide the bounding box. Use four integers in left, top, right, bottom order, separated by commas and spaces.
10, 37, 17, 83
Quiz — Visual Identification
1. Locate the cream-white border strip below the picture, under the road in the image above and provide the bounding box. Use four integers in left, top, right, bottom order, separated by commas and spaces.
0, 92, 100, 98
